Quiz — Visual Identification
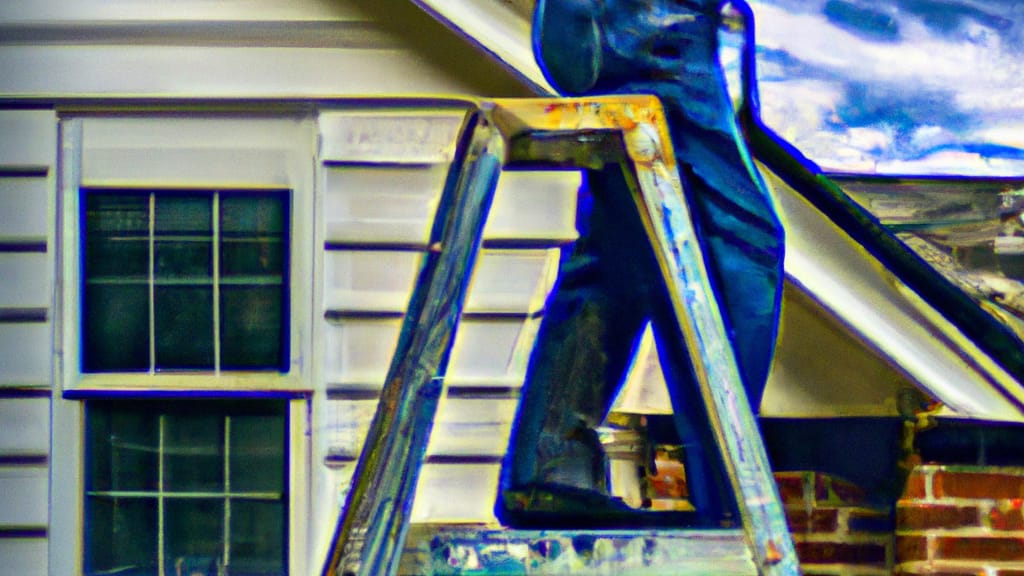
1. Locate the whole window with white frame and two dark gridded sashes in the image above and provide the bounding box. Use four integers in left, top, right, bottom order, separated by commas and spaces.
50, 114, 316, 576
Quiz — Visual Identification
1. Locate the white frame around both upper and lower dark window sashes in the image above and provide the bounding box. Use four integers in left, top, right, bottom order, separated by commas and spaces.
49, 110, 318, 575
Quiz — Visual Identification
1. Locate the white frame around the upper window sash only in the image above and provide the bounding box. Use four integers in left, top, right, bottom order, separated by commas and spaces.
58, 115, 315, 395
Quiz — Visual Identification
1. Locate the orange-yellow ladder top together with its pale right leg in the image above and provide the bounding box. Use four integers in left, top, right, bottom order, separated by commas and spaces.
492, 96, 800, 576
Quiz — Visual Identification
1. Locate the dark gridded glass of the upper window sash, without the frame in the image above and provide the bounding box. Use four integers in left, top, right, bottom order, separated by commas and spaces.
80, 189, 289, 372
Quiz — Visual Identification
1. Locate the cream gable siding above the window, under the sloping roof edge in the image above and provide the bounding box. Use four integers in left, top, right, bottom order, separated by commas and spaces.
0, 0, 527, 98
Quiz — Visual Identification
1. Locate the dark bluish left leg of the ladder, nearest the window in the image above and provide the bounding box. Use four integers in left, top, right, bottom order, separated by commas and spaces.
323, 111, 504, 576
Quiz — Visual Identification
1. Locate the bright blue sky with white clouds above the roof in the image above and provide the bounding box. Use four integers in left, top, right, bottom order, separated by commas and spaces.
732, 0, 1024, 176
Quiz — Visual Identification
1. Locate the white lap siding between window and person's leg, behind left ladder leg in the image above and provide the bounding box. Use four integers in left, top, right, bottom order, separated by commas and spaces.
314, 111, 580, 537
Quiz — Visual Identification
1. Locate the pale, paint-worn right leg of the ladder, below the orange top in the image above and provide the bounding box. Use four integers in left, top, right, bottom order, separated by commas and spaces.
624, 109, 800, 576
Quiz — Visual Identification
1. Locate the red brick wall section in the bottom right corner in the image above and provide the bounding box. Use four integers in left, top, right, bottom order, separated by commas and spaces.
896, 464, 1024, 576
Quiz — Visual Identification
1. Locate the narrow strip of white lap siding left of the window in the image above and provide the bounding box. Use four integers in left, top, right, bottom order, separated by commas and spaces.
0, 111, 56, 574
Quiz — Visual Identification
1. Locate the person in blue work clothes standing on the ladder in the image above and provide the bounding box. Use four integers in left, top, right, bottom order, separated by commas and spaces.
496, 0, 783, 528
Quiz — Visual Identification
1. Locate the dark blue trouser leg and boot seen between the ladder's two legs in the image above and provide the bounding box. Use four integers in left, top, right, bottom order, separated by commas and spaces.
496, 166, 728, 527
